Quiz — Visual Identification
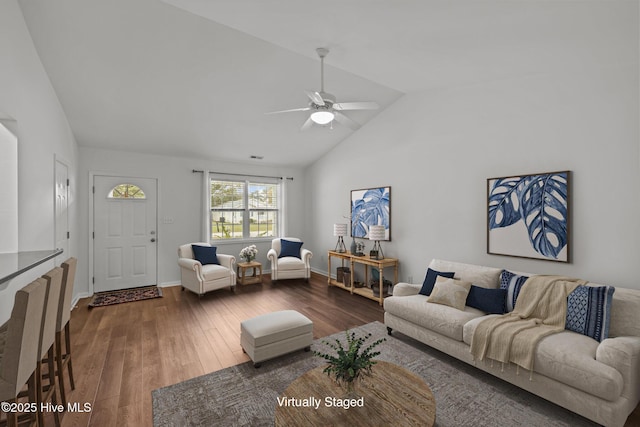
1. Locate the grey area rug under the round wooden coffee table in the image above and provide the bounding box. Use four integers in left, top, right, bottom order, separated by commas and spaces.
152, 322, 596, 427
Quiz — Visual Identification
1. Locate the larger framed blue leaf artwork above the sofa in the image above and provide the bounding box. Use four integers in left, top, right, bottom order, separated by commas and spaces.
487, 171, 571, 262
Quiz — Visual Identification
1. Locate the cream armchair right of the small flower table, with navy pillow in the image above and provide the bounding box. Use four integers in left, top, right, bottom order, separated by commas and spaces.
267, 237, 313, 282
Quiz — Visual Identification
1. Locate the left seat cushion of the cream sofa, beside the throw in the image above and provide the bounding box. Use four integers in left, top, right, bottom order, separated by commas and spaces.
384, 294, 485, 341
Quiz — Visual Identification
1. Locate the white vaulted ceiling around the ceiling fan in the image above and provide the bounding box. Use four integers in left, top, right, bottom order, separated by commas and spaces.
20, 0, 637, 166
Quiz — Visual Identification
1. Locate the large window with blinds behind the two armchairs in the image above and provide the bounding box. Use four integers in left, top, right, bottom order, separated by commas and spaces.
211, 179, 280, 240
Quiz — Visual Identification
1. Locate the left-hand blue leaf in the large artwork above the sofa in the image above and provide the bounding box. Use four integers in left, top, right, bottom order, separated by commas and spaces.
489, 176, 526, 230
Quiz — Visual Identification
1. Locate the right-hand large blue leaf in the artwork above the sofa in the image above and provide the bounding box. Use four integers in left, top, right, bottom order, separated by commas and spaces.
520, 174, 567, 258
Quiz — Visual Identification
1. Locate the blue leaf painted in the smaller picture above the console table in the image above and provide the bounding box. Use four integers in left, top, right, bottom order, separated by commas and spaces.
351, 188, 389, 237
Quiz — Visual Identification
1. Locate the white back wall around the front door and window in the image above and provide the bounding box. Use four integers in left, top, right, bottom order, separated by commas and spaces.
74, 147, 305, 298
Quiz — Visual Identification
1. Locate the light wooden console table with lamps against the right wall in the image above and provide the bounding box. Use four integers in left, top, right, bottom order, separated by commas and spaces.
327, 251, 398, 305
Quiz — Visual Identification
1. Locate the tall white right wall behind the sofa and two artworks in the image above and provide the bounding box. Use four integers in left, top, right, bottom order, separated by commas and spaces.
305, 64, 640, 288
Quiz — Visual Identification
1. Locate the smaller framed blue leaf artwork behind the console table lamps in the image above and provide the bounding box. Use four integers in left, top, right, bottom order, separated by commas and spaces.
351, 187, 391, 240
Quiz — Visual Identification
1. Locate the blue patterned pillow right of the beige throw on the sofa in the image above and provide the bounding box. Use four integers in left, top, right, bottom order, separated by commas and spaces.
565, 286, 615, 342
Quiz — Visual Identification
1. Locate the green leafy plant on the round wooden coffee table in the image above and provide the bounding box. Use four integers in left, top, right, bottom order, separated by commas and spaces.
313, 330, 386, 393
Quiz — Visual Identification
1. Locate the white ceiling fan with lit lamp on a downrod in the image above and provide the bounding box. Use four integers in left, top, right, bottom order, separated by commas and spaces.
266, 47, 379, 130
